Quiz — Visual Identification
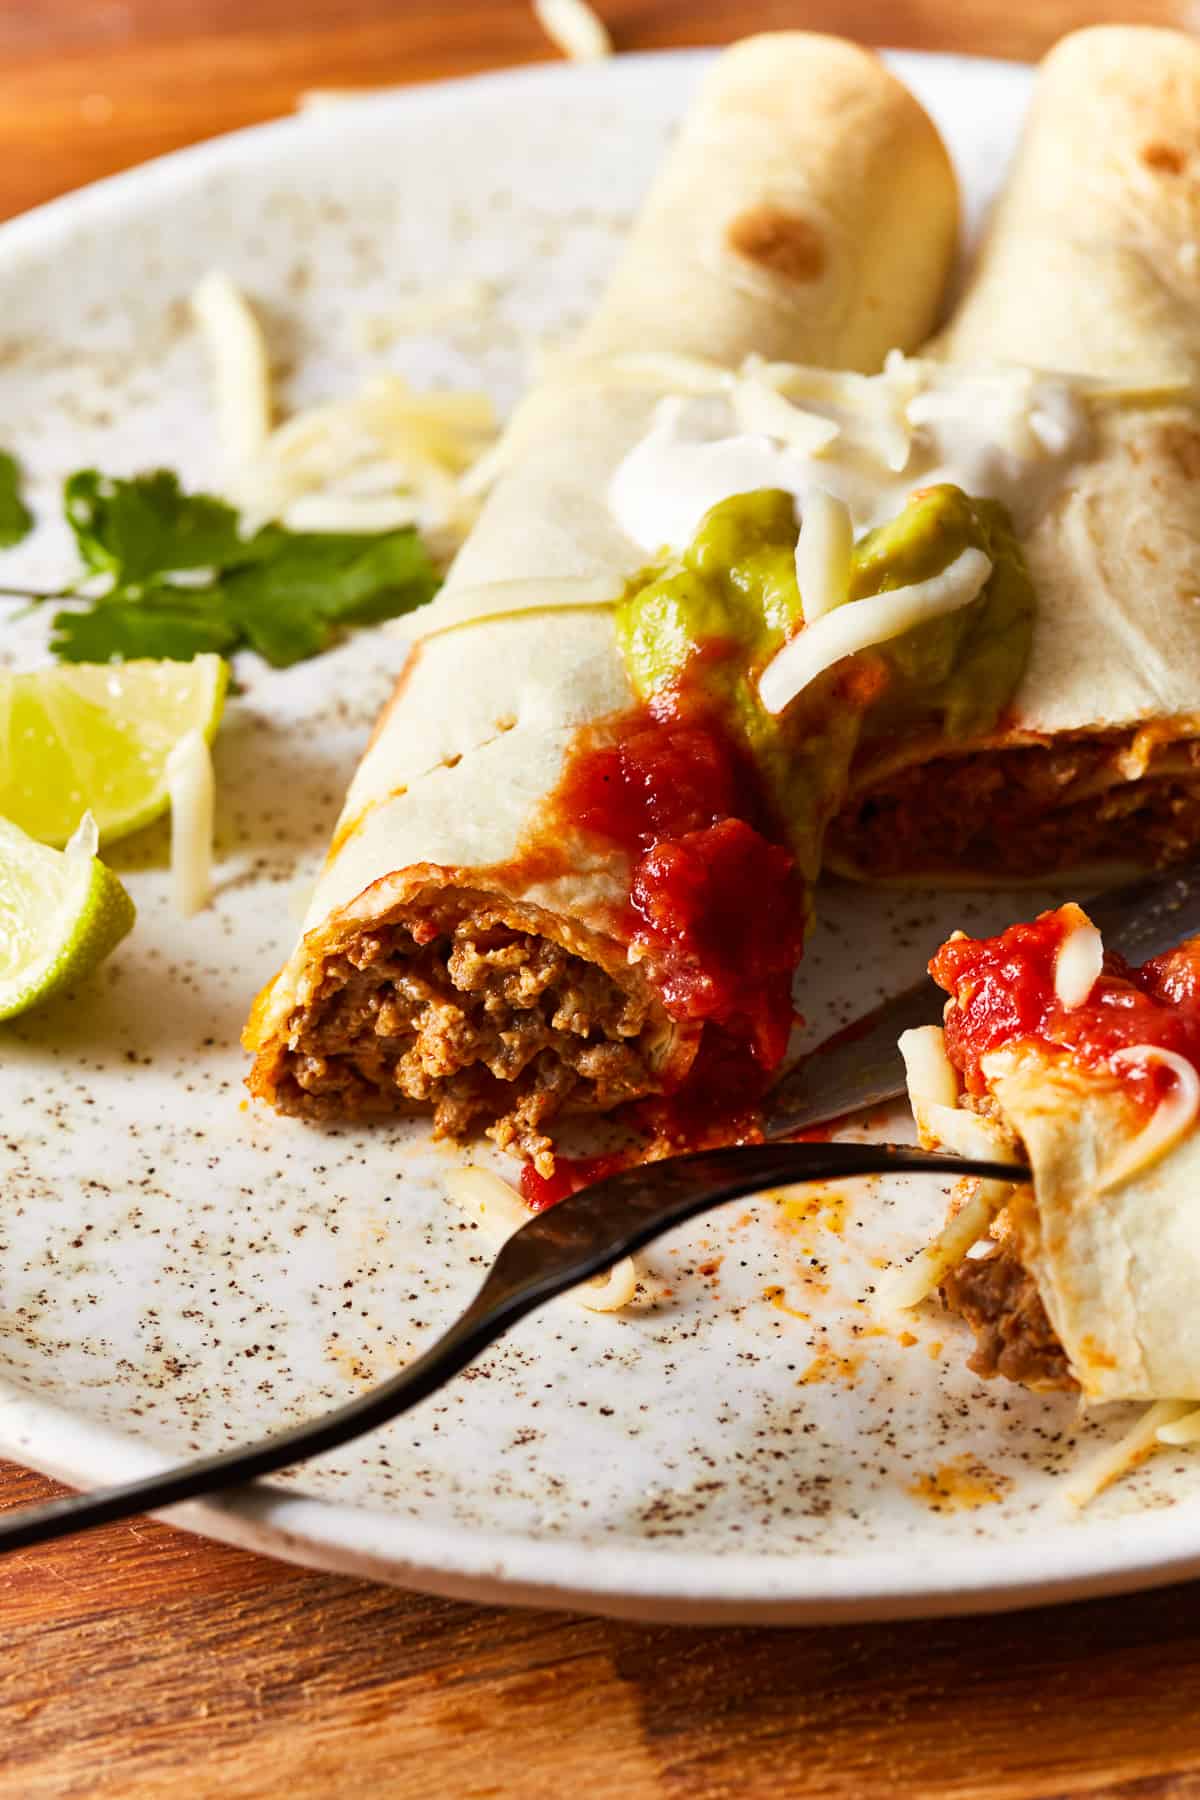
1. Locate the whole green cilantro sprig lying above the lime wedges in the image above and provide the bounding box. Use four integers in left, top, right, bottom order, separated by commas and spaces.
0, 454, 439, 668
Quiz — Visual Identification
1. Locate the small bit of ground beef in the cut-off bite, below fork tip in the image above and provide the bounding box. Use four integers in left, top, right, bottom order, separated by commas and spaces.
941, 1246, 1076, 1388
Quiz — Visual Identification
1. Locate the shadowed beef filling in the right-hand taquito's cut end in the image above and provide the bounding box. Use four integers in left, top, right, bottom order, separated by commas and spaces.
828, 740, 1200, 877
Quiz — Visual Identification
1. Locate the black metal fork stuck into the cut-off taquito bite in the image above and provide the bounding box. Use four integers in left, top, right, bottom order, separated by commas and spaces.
0, 1143, 1029, 1552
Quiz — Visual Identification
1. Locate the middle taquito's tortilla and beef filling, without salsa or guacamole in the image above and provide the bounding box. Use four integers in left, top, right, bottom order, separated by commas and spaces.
246, 34, 957, 1157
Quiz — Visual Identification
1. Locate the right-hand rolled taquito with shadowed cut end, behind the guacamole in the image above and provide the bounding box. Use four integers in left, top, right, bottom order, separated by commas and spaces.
828, 27, 1200, 880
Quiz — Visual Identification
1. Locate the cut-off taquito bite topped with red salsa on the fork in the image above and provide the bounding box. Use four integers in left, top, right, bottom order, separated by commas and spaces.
898, 905, 1200, 1400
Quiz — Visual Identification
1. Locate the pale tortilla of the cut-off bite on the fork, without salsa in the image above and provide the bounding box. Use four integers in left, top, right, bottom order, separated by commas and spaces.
984, 1046, 1200, 1400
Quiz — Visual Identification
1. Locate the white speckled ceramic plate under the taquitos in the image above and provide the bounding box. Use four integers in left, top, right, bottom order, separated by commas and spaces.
0, 54, 1200, 1622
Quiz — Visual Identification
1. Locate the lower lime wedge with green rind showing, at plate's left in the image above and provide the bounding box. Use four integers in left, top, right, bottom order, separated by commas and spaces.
0, 819, 133, 1019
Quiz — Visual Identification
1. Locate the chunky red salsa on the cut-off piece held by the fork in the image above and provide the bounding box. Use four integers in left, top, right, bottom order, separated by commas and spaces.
928, 907, 1200, 1105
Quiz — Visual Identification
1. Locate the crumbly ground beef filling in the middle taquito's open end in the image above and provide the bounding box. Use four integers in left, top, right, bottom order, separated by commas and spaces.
271, 914, 657, 1161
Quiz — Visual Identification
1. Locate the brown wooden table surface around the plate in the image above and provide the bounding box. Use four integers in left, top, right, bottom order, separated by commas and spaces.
0, 0, 1200, 1800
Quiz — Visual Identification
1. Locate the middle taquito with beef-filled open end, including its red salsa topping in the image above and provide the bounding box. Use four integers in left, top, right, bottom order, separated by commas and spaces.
246, 34, 957, 1166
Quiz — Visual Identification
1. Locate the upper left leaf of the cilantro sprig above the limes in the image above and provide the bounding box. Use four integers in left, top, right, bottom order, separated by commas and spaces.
63, 468, 255, 592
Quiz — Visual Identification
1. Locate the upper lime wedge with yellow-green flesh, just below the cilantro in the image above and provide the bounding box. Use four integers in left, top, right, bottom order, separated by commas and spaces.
0, 655, 228, 844
